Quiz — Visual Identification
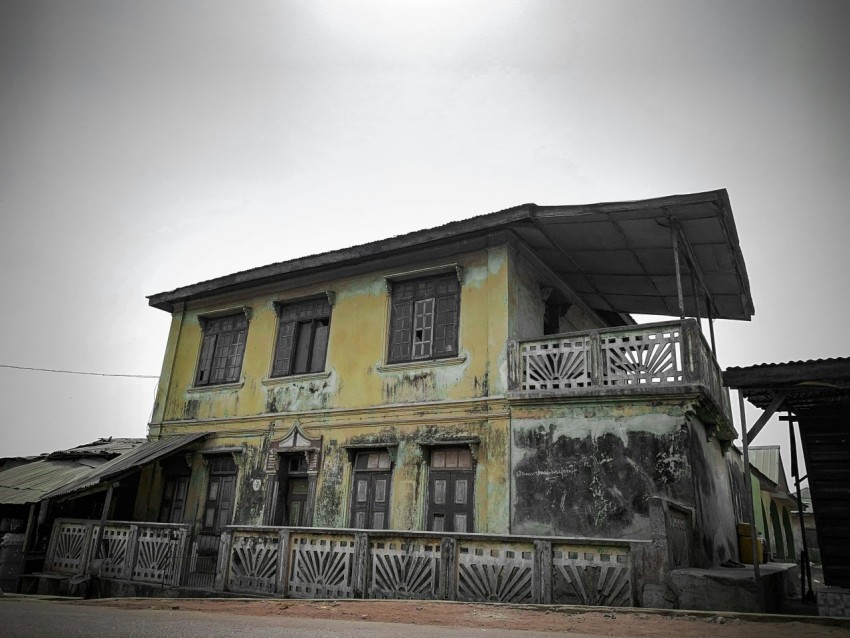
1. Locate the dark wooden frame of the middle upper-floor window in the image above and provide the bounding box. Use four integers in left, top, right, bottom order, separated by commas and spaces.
269, 292, 335, 379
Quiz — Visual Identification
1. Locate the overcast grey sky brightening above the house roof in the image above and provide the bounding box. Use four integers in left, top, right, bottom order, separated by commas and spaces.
0, 0, 850, 478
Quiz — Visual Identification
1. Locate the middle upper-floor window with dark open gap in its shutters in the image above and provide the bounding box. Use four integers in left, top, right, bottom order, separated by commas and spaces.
272, 298, 331, 377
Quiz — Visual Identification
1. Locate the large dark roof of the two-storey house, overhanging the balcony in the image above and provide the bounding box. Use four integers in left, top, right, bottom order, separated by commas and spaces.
148, 189, 755, 320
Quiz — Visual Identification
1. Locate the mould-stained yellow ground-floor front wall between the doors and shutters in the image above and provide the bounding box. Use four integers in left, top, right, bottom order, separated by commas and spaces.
152, 401, 509, 534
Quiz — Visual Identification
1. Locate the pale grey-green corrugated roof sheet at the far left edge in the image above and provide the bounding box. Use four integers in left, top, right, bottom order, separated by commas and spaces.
0, 459, 107, 505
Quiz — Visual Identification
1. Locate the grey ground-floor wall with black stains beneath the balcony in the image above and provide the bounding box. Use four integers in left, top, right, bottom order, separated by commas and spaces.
511, 398, 735, 562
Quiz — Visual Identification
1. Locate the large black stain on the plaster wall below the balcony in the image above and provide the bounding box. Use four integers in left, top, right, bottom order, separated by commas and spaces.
513, 425, 691, 537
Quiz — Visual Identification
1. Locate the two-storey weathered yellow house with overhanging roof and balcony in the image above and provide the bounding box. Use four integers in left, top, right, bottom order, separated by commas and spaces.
38, 190, 753, 603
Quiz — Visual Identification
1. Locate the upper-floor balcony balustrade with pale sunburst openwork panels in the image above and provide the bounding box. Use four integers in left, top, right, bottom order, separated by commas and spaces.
508, 319, 732, 427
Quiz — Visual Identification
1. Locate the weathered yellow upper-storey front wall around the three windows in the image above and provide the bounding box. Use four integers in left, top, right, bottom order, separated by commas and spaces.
152, 247, 508, 426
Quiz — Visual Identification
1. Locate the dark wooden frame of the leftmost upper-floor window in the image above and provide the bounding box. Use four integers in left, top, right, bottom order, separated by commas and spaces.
193, 308, 251, 388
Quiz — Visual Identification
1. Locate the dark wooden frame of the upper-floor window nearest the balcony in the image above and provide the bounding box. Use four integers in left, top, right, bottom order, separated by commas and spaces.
386, 274, 463, 364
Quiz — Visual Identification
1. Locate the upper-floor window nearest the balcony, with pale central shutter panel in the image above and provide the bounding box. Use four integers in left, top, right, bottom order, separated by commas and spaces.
388, 273, 460, 363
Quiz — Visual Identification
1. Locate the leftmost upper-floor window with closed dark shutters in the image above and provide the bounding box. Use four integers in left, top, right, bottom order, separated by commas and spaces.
195, 312, 248, 386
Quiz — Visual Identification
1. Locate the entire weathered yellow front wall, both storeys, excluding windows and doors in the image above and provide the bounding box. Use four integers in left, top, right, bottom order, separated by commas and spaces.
149, 246, 509, 533
